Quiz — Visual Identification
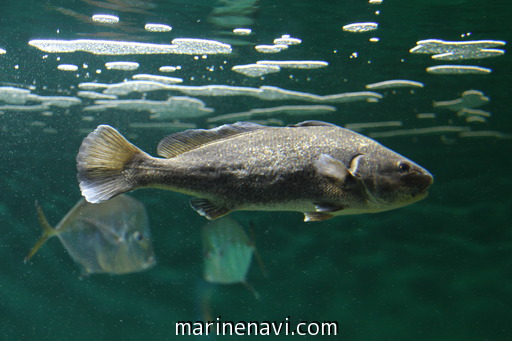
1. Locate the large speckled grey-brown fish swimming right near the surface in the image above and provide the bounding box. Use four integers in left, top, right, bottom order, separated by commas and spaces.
77, 121, 433, 221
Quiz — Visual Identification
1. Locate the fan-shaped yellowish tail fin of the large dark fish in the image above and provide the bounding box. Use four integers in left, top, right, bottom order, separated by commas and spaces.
76, 125, 148, 204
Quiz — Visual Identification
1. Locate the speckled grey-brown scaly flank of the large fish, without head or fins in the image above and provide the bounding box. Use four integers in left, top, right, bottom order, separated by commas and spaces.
128, 127, 368, 203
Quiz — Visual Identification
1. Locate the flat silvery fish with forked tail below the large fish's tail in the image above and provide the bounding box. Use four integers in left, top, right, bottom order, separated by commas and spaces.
25, 195, 156, 276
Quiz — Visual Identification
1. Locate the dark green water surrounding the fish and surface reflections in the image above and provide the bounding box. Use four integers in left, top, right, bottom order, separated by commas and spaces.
0, 0, 512, 341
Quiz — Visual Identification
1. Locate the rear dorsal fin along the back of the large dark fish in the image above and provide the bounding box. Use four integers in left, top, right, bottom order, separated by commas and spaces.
157, 122, 268, 158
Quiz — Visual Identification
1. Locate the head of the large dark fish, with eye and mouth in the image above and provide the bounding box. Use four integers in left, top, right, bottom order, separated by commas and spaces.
357, 150, 434, 211
